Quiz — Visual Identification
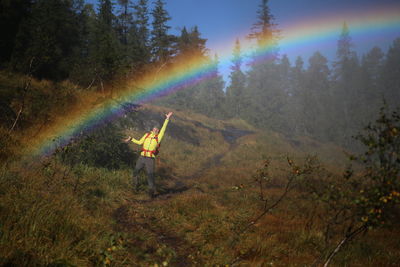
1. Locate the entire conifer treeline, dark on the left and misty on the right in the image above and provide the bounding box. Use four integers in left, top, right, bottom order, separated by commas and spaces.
0, 0, 400, 149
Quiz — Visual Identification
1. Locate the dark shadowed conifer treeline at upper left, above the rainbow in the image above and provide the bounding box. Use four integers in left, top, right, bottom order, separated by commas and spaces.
0, 0, 178, 82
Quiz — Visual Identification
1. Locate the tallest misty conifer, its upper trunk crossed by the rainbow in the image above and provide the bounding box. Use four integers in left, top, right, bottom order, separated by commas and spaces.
244, 0, 287, 130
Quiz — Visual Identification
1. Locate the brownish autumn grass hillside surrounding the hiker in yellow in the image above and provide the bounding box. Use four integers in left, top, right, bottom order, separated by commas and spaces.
0, 74, 400, 266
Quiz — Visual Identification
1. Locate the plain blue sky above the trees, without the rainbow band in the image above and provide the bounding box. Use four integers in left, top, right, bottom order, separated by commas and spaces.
87, 0, 400, 79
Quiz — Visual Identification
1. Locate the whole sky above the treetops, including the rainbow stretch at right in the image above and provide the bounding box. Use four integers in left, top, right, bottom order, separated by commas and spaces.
87, 0, 400, 80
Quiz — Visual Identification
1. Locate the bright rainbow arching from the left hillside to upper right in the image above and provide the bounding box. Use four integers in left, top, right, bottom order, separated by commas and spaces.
28, 4, 400, 156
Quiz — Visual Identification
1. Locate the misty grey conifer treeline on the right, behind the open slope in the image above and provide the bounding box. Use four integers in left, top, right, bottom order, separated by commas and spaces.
162, 0, 400, 148
